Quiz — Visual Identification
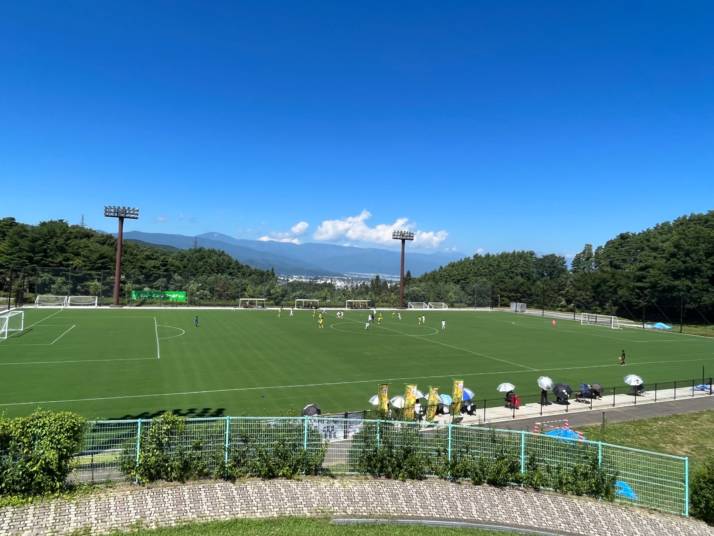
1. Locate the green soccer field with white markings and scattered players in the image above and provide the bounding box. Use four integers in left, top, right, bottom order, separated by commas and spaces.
0, 308, 714, 418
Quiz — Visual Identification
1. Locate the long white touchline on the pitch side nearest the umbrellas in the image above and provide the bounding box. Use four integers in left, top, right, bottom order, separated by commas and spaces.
0, 357, 714, 407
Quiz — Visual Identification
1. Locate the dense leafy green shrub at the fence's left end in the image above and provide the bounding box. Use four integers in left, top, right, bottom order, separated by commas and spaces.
0, 411, 84, 495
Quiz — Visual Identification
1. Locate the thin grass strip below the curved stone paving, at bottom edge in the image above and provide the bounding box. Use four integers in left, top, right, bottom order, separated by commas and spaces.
104, 518, 519, 536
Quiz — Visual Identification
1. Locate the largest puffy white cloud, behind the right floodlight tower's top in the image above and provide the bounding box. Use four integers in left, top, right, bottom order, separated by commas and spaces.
314, 210, 449, 249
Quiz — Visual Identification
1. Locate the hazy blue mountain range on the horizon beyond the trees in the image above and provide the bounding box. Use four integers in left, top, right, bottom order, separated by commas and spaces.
124, 231, 463, 277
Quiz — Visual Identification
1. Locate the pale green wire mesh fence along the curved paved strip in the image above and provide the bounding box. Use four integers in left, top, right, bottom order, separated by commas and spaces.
71, 416, 689, 516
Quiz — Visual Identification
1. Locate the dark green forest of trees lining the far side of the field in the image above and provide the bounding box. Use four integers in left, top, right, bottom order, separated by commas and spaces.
0, 211, 714, 323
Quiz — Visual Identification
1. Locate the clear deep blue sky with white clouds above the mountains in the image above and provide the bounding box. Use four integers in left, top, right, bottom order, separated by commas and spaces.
0, 1, 714, 254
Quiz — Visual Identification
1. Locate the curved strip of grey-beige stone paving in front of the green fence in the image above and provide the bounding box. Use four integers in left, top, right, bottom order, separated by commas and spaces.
0, 478, 714, 536
